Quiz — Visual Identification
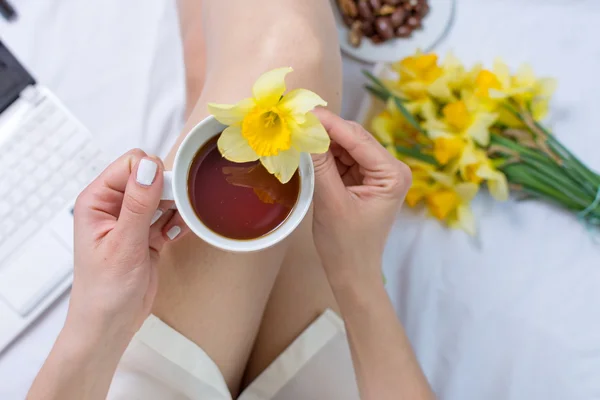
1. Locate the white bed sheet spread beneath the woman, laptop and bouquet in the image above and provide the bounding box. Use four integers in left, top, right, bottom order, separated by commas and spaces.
0, 0, 600, 400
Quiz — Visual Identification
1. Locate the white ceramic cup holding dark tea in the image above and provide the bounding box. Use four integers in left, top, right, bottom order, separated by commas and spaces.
162, 117, 315, 253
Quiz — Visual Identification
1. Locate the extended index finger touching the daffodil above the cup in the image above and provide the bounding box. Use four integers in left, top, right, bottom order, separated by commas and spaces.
314, 108, 393, 170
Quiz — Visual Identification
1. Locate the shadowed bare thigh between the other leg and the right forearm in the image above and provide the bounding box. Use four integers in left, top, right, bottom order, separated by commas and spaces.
243, 211, 339, 387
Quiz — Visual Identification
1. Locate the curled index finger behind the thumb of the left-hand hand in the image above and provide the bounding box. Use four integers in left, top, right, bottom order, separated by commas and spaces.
75, 149, 146, 230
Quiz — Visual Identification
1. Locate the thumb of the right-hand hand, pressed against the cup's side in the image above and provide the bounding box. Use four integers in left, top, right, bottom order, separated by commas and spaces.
312, 150, 345, 204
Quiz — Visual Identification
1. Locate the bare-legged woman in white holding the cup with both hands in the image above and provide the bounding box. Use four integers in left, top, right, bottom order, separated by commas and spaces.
30, 0, 432, 400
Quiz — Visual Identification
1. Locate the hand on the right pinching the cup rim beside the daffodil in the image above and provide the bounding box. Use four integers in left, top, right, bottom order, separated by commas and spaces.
313, 109, 412, 279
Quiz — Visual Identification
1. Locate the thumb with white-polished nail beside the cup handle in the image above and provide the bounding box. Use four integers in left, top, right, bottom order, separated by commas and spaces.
116, 157, 164, 243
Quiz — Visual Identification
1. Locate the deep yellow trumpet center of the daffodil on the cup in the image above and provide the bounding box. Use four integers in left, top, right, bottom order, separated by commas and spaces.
242, 107, 292, 157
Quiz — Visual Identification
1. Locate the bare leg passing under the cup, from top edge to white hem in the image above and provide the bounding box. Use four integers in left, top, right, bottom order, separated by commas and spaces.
153, 0, 342, 396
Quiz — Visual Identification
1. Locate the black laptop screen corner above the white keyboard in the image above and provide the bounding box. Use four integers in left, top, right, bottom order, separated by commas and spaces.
0, 41, 35, 113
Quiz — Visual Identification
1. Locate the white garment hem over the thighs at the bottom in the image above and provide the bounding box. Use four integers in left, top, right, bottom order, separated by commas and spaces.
108, 310, 358, 400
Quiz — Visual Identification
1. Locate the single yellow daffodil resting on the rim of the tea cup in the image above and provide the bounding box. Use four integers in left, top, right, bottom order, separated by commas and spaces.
208, 68, 329, 183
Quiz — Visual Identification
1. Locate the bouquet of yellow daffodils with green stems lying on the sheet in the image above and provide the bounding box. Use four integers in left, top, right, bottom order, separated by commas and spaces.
366, 53, 600, 234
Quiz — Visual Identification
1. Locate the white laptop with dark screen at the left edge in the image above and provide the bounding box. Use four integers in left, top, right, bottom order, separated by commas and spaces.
0, 41, 107, 353
